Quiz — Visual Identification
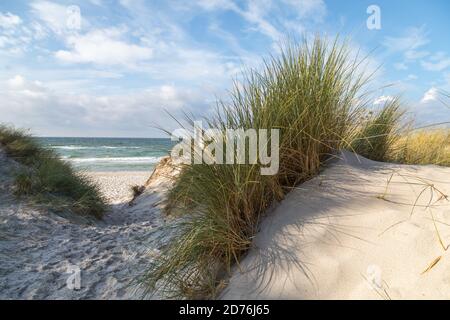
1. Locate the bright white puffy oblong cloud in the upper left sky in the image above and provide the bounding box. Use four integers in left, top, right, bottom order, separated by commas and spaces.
55, 28, 153, 67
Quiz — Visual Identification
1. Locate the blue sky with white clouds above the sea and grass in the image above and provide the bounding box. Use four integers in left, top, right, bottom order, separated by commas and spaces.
0, 0, 450, 137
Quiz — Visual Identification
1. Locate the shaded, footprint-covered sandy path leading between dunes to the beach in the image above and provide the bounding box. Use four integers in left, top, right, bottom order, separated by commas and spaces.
0, 152, 172, 299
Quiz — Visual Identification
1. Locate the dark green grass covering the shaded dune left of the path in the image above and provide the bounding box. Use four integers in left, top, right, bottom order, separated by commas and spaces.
0, 126, 106, 219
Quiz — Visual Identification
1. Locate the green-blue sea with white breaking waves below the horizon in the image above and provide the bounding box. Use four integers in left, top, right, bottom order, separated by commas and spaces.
37, 138, 174, 172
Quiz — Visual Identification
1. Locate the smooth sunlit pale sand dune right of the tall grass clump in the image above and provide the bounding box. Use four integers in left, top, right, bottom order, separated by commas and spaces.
222, 153, 450, 299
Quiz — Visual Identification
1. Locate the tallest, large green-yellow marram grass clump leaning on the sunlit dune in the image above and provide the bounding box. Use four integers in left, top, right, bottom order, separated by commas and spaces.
140, 38, 406, 298
